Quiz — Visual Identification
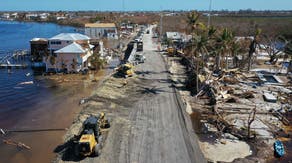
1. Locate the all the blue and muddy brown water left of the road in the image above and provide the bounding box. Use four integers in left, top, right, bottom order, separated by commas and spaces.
0, 21, 94, 163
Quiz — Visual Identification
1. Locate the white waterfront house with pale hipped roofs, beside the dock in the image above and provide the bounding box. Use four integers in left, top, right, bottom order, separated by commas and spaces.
43, 33, 94, 72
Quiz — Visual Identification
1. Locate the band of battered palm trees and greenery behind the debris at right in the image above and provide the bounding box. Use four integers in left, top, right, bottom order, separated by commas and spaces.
185, 12, 292, 92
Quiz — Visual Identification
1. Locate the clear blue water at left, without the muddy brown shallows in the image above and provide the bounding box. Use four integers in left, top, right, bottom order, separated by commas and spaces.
0, 21, 75, 127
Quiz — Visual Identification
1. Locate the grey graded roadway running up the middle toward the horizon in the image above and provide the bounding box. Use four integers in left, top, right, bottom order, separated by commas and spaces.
114, 26, 206, 163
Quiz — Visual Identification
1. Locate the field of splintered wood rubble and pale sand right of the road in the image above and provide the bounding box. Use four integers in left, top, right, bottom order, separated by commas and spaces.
162, 49, 292, 162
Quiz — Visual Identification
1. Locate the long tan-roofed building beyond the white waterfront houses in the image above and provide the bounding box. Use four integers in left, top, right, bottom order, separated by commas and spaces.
85, 23, 118, 39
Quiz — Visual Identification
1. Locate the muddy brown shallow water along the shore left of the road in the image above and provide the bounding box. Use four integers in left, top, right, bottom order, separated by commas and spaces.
0, 70, 105, 163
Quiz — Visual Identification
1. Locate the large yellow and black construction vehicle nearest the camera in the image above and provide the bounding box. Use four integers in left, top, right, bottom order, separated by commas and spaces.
75, 113, 110, 157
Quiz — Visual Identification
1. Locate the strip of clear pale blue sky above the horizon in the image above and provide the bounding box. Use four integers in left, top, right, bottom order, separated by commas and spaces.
0, 0, 292, 11
